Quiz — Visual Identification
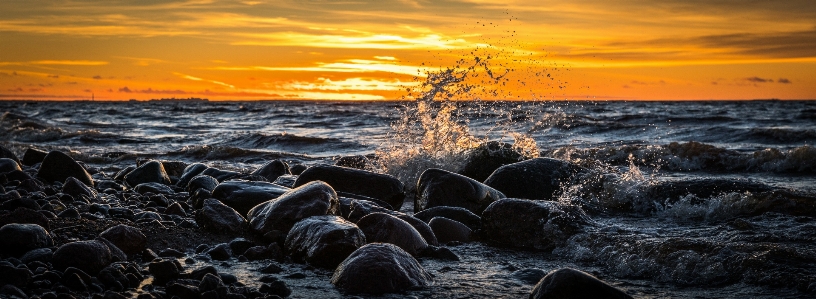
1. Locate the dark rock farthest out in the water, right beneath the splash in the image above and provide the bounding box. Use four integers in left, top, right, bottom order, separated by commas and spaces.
459, 141, 524, 182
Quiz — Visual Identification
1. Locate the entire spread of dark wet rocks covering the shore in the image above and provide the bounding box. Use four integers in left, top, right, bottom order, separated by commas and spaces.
0, 147, 626, 299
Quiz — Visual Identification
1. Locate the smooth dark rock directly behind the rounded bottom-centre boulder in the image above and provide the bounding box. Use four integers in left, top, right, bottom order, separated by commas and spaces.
357, 213, 428, 255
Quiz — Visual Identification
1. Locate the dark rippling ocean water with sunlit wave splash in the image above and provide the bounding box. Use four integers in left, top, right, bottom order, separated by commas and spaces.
0, 100, 816, 298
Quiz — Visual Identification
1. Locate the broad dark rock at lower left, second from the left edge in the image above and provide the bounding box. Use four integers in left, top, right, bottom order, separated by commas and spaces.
51, 240, 112, 275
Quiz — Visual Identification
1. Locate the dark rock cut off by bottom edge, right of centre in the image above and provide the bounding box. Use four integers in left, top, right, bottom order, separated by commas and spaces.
529, 268, 632, 299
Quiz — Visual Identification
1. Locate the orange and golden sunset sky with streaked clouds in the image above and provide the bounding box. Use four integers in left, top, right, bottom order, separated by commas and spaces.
0, 0, 816, 100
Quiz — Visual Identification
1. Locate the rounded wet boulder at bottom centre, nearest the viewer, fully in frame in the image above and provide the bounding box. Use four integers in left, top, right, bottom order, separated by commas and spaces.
331, 243, 433, 294
